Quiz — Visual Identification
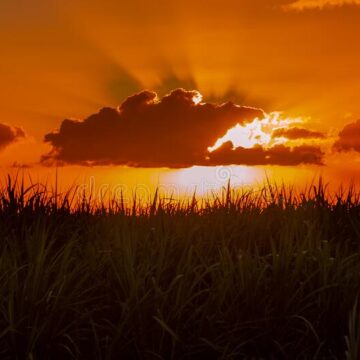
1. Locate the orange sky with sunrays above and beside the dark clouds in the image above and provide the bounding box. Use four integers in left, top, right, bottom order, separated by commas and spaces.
0, 0, 360, 194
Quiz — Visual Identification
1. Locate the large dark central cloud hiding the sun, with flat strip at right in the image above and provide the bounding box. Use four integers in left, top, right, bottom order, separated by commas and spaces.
42, 89, 322, 168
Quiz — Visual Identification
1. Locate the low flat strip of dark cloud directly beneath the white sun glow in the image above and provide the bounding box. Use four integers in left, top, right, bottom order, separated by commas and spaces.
209, 142, 324, 166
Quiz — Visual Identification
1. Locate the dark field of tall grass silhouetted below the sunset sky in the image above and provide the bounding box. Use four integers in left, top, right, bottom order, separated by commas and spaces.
0, 179, 360, 360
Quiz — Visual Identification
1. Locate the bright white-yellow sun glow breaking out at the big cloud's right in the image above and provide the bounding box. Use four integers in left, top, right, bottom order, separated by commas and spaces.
208, 112, 303, 152
